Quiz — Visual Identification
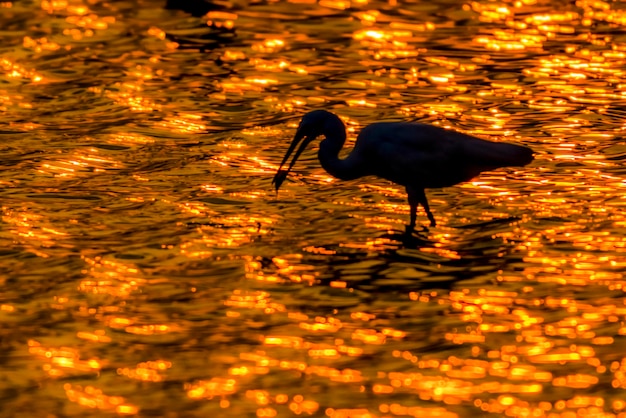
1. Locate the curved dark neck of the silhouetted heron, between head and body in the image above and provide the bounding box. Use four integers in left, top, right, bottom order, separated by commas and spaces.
317, 123, 362, 180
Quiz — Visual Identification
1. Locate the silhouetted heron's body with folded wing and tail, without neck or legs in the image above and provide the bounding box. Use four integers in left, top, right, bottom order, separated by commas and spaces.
353, 123, 532, 187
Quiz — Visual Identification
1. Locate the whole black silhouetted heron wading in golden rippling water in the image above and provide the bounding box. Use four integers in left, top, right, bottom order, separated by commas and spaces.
272, 110, 534, 233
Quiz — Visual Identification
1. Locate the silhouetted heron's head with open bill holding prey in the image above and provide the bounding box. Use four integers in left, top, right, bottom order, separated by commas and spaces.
272, 110, 339, 192
